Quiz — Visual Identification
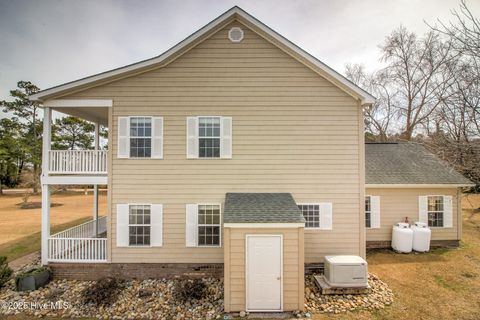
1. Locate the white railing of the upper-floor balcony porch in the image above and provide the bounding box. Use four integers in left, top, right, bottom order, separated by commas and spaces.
48, 150, 107, 174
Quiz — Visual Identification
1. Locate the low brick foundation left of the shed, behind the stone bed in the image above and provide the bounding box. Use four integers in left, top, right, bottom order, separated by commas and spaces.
49, 263, 223, 280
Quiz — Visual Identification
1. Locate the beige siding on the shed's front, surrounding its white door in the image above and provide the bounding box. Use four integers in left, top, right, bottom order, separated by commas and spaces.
224, 228, 304, 311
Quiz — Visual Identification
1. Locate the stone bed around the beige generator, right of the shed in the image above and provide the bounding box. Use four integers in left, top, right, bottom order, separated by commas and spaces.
305, 274, 393, 316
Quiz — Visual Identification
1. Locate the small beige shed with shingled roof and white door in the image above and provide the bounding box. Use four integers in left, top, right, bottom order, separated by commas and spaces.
224, 193, 305, 312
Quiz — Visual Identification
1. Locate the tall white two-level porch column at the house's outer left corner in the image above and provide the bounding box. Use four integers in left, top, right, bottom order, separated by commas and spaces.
41, 107, 52, 265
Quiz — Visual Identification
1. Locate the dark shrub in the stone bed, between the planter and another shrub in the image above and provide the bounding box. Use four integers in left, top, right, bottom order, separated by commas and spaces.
82, 277, 122, 306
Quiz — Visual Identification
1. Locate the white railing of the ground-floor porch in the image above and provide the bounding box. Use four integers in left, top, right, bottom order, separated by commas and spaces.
48, 217, 107, 263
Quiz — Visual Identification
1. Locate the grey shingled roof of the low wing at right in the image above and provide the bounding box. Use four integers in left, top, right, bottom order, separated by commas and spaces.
365, 142, 473, 186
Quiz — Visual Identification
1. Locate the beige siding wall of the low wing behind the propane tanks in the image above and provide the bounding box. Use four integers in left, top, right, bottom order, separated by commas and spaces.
365, 188, 461, 241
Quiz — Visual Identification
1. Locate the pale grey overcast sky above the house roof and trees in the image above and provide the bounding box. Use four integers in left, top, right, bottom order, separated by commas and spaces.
0, 0, 480, 100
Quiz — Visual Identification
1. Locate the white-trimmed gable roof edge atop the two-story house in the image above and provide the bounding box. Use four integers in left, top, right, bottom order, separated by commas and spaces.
30, 6, 375, 104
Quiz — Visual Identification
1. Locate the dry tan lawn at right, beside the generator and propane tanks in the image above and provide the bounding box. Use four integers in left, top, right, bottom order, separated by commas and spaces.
314, 201, 480, 320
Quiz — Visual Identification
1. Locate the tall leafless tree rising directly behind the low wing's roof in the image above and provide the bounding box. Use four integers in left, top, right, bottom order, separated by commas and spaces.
380, 26, 453, 140
